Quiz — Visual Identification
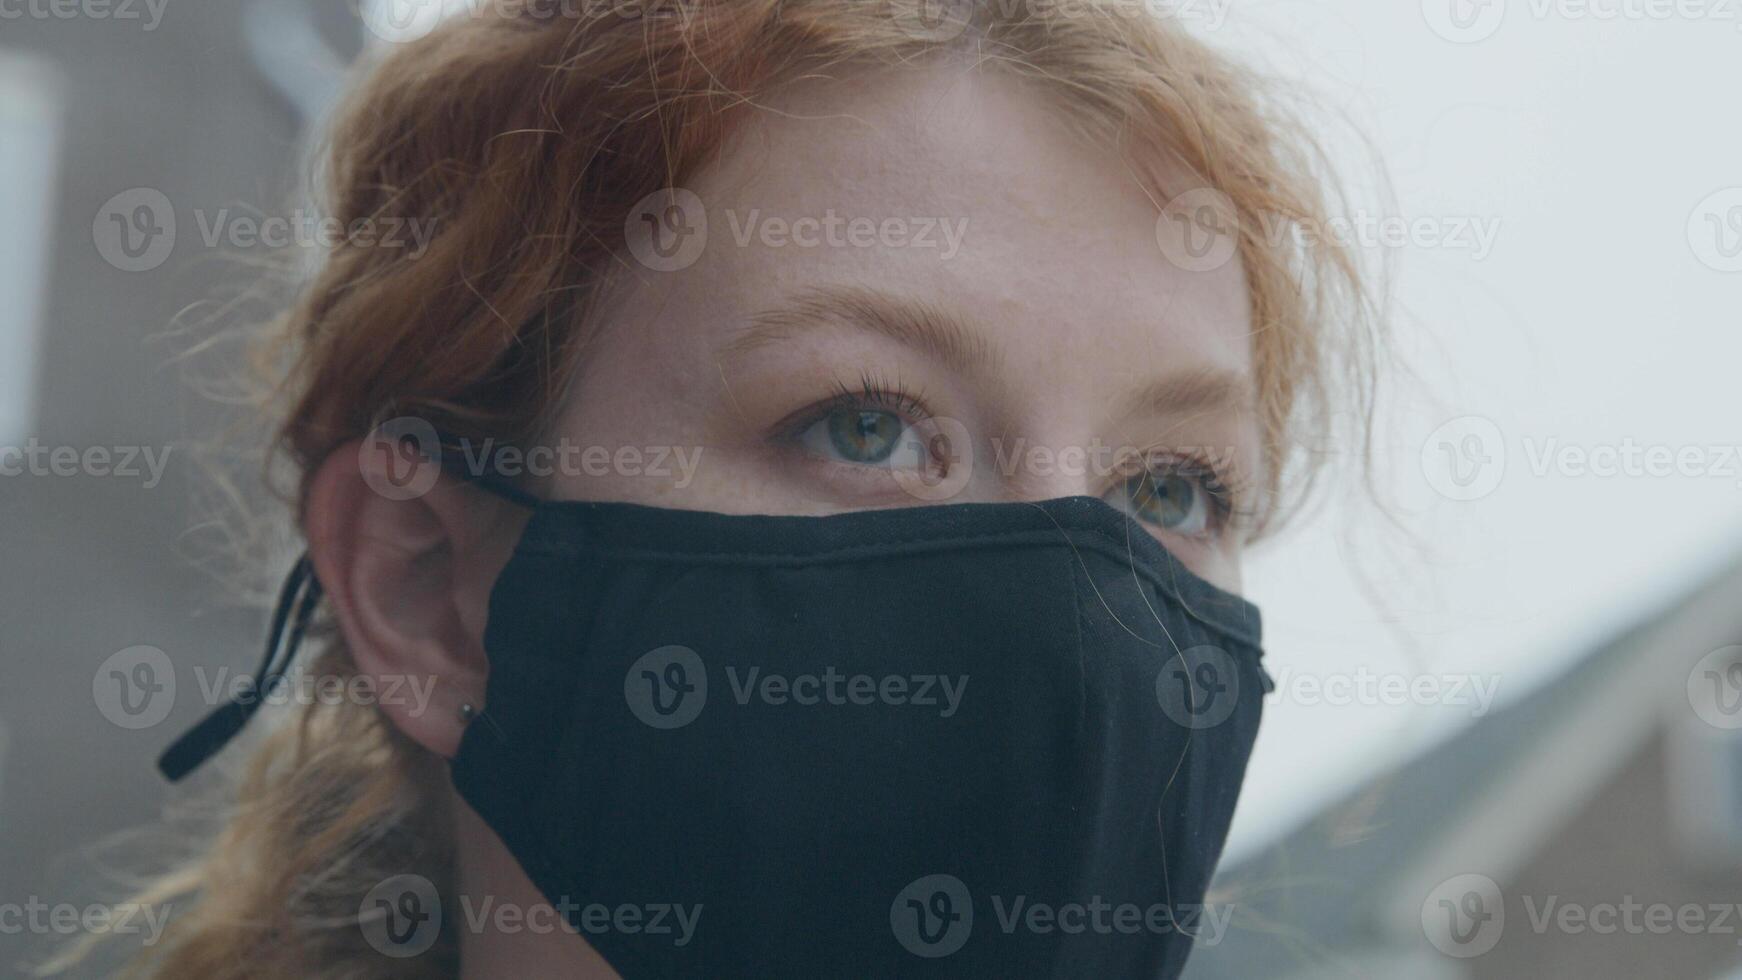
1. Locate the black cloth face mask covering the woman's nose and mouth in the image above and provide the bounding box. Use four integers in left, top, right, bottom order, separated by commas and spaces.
164, 466, 1272, 980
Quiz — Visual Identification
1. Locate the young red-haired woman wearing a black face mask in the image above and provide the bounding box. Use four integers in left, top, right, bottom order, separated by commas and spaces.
74, 0, 1367, 978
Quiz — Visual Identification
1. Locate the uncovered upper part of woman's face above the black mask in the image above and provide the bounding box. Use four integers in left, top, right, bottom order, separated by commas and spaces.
547, 66, 1258, 590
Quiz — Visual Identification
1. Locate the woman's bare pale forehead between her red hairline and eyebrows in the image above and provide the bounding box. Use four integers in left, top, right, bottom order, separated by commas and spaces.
599, 66, 1251, 407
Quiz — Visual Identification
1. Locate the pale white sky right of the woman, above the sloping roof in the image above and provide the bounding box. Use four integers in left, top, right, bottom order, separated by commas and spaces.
1211, 0, 1742, 855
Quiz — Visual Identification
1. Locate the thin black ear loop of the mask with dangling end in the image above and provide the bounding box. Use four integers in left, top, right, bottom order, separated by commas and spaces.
157, 439, 544, 783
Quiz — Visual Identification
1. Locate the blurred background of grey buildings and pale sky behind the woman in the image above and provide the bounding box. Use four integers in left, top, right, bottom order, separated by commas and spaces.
0, 0, 1742, 978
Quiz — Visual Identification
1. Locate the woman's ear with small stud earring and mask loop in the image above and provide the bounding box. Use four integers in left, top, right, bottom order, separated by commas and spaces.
303, 435, 514, 757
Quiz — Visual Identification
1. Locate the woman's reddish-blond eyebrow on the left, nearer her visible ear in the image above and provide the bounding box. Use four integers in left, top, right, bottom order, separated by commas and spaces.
719, 285, 998, 374
